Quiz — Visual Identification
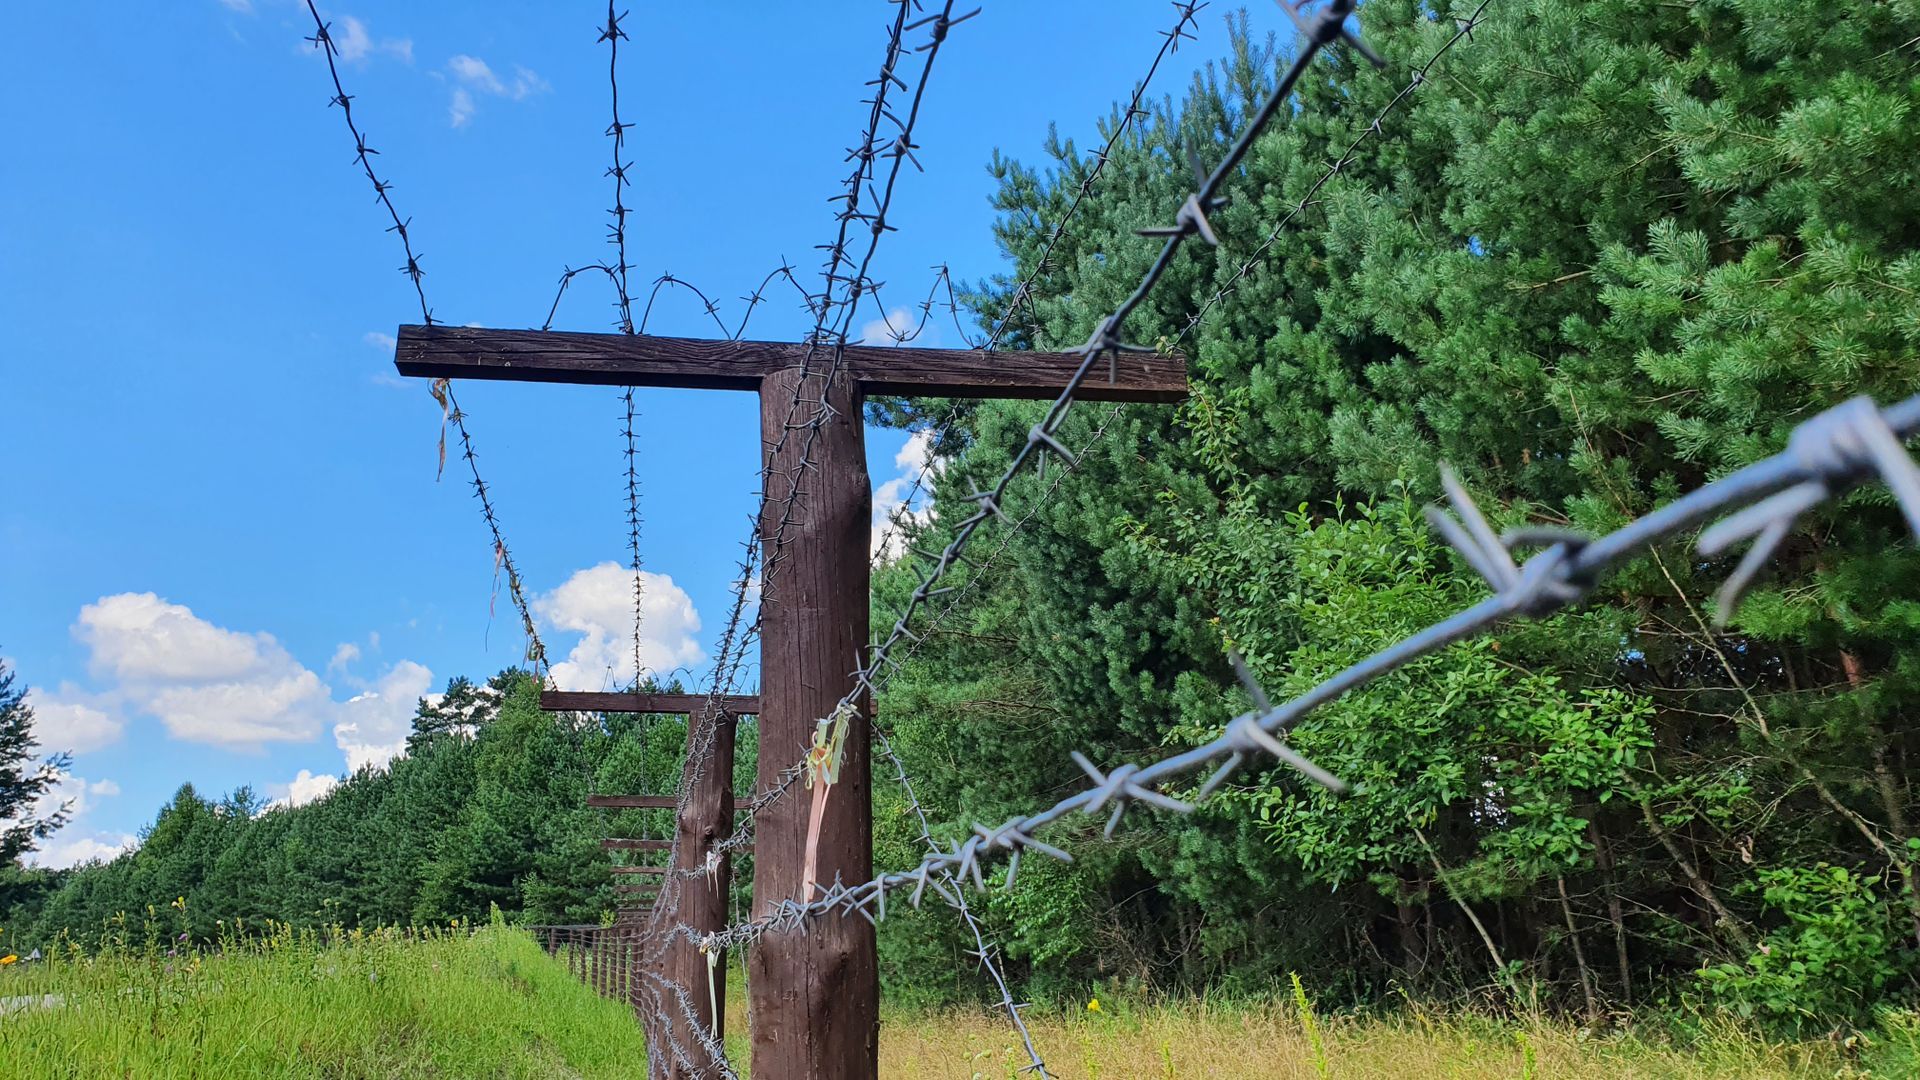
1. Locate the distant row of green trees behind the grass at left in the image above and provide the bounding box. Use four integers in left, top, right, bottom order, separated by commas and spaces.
0, 671, 753, 949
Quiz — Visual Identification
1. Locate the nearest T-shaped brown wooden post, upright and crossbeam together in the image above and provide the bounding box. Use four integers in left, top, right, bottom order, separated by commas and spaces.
394, 327, 1187, 1080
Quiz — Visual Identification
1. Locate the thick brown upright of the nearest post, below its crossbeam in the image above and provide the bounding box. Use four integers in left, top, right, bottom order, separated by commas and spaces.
747, 369, 879, 1080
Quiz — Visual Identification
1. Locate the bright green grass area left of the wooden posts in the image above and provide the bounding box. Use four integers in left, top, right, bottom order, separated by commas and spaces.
0, 914, 645, 1080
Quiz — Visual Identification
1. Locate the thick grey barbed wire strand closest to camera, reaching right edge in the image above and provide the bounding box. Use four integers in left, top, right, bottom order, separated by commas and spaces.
698, 396, 1920, 945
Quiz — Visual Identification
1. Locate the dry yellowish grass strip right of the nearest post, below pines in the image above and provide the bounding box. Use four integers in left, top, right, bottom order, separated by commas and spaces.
879, 990, 1920, 1080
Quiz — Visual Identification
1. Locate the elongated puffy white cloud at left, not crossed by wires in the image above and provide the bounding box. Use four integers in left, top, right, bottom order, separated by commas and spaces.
73, 592, 332, 748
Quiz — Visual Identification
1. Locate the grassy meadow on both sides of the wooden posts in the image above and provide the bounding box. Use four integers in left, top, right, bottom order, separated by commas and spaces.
0, 924, 1920, 1080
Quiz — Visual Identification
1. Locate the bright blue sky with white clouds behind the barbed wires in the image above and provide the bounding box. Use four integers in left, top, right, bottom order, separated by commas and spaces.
0, 0, 1213, 865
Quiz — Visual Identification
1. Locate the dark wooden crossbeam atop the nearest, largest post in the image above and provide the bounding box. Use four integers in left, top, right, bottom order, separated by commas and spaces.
394, 327, 1187, 402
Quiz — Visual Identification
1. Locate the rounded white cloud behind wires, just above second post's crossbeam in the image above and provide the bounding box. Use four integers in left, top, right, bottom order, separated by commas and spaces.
534, 561, 707, 690
